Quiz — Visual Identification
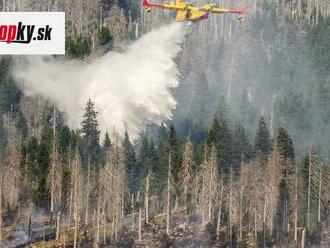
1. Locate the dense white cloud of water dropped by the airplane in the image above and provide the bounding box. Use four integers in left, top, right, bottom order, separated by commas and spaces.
14, 23, 184, 136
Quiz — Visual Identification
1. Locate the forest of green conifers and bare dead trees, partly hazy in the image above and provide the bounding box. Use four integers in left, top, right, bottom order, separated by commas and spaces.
0, 0, 330, 248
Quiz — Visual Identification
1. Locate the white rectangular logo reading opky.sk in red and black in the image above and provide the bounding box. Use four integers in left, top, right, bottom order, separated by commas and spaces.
0, 12, 65, 54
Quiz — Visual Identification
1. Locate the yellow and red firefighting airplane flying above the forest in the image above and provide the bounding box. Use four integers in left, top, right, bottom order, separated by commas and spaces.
143, 0, 245, 22
